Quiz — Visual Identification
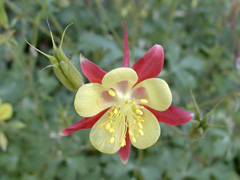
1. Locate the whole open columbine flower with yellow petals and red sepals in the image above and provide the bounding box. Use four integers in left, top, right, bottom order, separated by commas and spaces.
62, 23, 192, 164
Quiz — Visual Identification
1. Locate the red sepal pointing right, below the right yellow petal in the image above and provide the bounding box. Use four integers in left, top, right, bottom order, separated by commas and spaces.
146, 106, 193, 125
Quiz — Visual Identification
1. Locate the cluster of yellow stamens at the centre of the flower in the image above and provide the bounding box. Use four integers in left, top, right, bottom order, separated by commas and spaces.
99, 90, 148, 147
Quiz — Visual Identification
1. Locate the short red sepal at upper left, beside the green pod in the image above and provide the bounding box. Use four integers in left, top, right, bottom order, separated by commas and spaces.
80, 55, 106, 84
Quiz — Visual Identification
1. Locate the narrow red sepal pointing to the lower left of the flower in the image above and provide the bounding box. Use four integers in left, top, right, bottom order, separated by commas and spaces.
61, 108, 109, 136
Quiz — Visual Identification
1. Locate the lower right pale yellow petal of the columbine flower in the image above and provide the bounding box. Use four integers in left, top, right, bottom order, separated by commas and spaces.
128, 108, 161, 149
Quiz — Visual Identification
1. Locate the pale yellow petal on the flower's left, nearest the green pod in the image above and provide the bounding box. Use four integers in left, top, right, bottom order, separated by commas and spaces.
74, 83, 116, 117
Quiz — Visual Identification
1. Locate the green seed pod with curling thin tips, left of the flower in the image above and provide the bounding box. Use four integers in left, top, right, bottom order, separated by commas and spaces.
27, 24, 83, 91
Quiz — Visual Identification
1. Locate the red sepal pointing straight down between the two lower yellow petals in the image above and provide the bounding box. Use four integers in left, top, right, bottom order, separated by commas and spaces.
118, 131, 131, 166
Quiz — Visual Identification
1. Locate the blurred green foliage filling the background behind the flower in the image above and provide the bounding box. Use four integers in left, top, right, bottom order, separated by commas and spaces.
0, 0, 240, 180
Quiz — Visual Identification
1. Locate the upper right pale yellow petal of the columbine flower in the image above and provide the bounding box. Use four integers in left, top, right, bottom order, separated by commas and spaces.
132, 78, 172, 111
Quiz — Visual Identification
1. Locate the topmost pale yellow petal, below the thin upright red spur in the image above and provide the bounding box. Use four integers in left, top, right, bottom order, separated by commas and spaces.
102, 67, 138, 91
